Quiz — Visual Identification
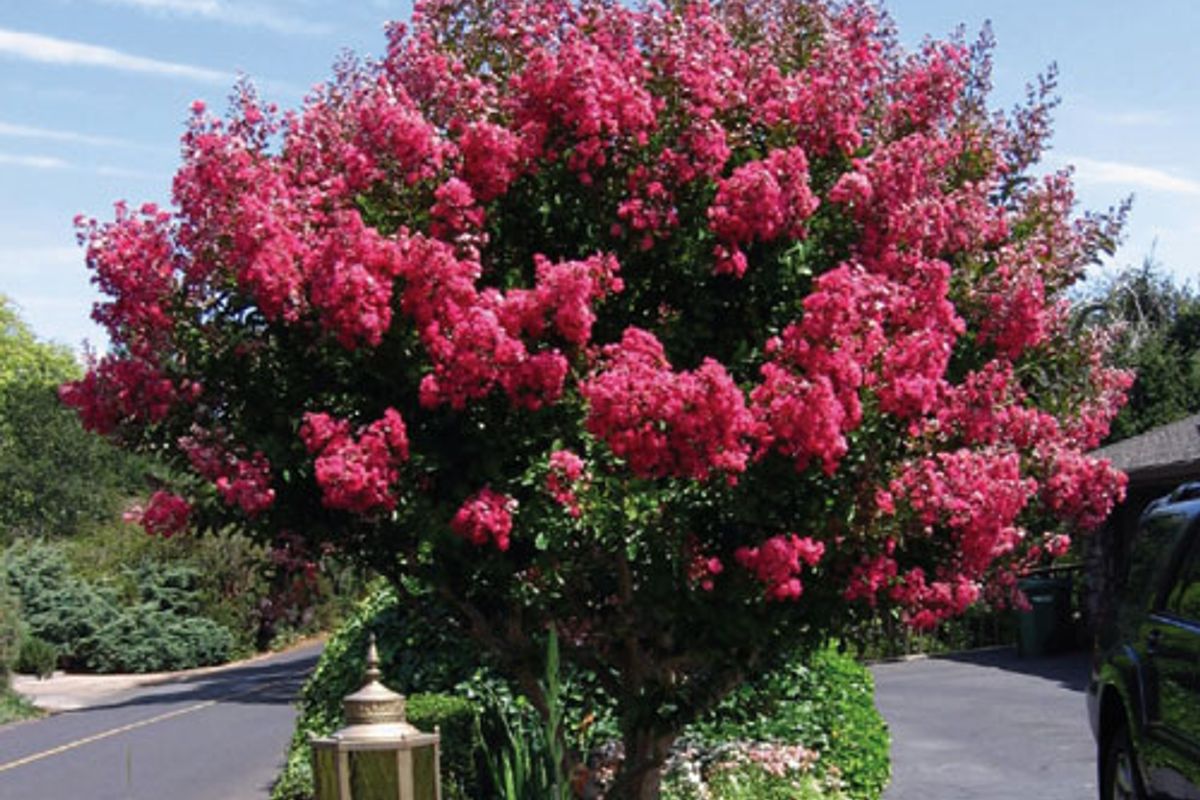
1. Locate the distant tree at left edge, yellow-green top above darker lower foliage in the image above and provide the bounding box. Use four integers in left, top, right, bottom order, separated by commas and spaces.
0, 296, 143, 543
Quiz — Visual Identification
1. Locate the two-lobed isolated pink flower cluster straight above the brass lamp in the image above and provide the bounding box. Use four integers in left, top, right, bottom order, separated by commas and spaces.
300, 408, 408, 515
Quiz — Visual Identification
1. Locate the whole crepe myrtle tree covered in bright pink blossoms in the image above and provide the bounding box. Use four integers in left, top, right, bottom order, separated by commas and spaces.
61, 0, 1129, 798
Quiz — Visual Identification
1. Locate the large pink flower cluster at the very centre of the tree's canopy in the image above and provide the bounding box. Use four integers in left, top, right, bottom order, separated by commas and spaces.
580, 327, 755, 481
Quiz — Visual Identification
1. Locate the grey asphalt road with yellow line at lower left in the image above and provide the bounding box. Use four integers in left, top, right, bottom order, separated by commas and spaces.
0, 644, 322, 800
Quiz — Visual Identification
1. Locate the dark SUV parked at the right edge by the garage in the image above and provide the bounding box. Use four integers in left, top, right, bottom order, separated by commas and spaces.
1087, 483, 1200, 800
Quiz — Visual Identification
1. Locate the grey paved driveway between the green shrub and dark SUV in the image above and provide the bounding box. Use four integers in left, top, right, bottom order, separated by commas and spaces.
871, 649, 1097, 800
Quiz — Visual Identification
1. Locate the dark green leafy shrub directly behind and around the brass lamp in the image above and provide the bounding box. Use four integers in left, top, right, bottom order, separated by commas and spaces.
271, 584, 481, 800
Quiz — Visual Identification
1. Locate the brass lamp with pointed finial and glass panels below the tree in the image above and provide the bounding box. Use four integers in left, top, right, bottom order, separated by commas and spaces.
312, 633, 442, 800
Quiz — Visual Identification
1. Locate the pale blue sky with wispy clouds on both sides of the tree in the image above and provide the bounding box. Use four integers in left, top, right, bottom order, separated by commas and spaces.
0, 0, 1200, 349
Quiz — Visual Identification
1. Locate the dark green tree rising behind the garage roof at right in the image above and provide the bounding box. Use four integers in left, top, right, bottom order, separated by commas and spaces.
1075, 254, 1200, 441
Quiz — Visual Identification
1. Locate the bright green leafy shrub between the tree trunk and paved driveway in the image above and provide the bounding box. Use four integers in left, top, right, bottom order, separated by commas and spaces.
686, 649, 892, 800
